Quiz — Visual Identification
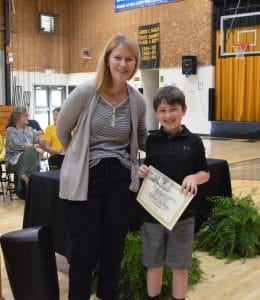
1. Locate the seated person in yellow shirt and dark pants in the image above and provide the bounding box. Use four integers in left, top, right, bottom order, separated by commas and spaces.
41, 107, 64, 169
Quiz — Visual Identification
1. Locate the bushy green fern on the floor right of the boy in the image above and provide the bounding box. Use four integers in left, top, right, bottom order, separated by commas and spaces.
196, 194, 260, 260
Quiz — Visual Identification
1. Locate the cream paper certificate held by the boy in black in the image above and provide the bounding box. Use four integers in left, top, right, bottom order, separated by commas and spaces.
137, 166, 194, 230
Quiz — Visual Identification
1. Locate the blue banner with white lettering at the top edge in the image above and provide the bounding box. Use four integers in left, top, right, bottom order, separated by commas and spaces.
114, 0, 176, 12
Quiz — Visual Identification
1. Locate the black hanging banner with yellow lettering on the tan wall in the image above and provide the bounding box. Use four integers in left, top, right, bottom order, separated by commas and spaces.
138, 23, 160, 69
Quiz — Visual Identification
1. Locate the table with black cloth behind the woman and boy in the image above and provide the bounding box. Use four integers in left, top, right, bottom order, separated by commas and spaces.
23, 158, 232, 257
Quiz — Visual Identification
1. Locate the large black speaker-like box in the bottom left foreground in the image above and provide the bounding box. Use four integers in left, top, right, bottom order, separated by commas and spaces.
0, 226, 59, 300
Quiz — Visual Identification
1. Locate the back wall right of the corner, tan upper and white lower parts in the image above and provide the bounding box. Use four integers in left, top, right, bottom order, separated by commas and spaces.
68, 0, 214, 134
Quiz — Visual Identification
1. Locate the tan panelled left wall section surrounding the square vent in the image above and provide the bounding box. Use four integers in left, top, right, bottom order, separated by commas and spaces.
12, 0, 70, 73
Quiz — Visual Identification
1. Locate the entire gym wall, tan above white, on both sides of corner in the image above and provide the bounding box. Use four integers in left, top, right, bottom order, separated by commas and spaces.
0, 0, 214, 133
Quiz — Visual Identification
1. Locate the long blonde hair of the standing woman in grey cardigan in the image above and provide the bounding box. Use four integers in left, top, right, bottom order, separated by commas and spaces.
95, 34, 140, 93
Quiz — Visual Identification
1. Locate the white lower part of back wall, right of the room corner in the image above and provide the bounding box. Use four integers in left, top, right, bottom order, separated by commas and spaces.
68, 66, 215, 134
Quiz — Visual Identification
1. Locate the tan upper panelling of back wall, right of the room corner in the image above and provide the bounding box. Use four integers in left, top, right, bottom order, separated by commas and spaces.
68, 0, 211, 72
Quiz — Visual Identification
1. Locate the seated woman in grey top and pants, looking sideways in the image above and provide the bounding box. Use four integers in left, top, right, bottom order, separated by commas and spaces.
5, 107, 43, 199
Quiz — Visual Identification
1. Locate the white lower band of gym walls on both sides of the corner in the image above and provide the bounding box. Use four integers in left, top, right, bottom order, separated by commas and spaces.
3, 66, 215, 134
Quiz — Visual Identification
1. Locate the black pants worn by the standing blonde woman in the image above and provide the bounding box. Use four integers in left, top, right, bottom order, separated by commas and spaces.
63, 158, 135, 300
